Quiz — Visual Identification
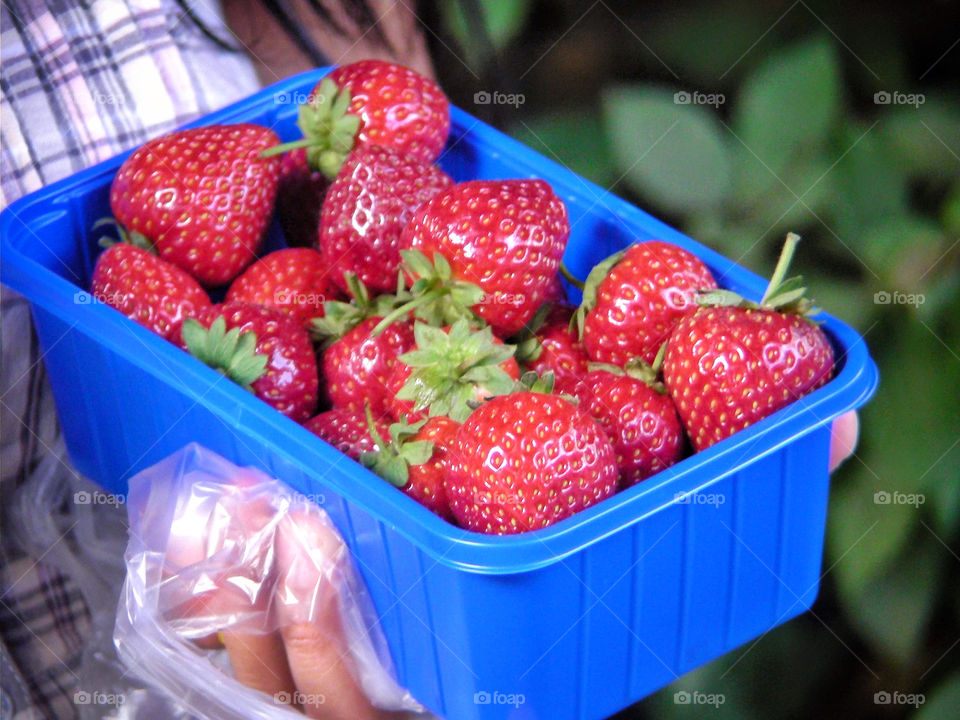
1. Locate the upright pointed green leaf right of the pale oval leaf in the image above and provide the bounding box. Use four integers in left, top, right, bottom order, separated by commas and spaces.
733, 37, 840, 185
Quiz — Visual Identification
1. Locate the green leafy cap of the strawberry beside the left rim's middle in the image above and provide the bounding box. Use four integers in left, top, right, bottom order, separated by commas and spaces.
182, 315, 268, 392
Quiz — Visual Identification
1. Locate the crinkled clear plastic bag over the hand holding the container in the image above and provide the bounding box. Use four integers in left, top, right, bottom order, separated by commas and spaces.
114, 444, 422, 720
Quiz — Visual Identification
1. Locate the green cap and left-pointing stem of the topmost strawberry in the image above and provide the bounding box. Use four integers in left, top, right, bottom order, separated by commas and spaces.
260, 77, 360, 180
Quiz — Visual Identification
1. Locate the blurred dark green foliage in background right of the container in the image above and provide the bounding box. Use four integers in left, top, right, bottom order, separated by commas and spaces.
441, 0, 960, 720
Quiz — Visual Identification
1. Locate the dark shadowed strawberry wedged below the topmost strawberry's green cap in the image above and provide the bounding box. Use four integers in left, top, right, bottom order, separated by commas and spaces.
276, 148, 330, 247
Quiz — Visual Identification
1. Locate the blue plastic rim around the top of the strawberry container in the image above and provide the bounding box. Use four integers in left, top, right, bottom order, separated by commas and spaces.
0, 68, 878, 575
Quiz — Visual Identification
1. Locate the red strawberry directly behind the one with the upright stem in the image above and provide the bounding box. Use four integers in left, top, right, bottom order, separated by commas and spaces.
577, 240, 717, 365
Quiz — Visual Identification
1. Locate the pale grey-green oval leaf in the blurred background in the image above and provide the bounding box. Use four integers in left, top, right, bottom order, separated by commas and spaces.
602, 85, 731, 212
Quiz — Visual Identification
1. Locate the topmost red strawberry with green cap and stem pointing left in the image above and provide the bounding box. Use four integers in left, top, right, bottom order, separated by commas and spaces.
256, 60, 450, 180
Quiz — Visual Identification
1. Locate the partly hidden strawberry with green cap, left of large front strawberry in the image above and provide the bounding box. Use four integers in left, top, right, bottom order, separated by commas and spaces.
360, 417, 460, 520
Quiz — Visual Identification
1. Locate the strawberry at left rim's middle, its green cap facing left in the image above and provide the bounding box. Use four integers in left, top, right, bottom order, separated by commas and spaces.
182, 303, 319, 422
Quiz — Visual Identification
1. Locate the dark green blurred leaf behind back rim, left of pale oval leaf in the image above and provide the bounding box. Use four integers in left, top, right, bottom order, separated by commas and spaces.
505, 110, 619, 187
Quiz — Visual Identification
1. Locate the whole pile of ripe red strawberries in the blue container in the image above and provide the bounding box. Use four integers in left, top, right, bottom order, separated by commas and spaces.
92, 60, 833, 534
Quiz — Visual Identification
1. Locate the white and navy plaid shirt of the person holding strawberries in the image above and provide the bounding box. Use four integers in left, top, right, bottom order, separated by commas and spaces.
0, 0, 258, 718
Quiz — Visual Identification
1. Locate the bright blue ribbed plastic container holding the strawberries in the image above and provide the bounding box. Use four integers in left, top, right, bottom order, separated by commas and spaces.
0, 71, 877, 720
